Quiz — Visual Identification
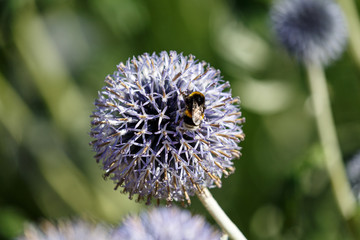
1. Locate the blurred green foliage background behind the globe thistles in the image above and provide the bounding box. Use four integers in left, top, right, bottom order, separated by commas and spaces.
0, 0, 360, 240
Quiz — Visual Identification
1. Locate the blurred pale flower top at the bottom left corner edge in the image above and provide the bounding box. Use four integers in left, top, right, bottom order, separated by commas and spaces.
18, 220, 111, 240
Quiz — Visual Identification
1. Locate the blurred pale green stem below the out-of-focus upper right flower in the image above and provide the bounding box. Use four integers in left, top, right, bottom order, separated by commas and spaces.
306, 63, 356, 220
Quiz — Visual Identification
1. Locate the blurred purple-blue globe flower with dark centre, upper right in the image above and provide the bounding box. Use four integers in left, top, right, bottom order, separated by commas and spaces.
271, 0, 347, 65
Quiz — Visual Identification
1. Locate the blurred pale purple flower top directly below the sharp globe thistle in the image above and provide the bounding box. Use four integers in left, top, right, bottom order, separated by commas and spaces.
112, 208, 221, 240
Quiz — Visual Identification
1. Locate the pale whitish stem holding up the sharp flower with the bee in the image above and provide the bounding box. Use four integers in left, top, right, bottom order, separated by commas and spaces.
197, 188, 246, 240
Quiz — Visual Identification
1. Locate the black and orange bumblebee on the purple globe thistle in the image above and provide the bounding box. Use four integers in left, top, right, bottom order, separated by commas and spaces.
184, 92, 205, 130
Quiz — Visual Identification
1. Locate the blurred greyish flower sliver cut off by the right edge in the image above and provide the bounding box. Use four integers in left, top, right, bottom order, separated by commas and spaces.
346, 152, 360, 201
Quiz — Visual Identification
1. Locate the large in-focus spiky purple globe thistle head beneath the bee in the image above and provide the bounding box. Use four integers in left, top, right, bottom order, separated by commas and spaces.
91, 51, 244, 203
